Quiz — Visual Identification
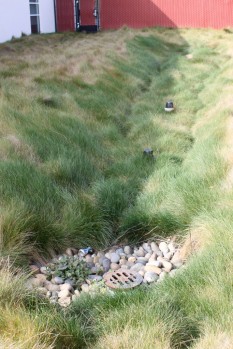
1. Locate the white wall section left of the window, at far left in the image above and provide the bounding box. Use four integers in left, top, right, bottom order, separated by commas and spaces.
0, 0, 31, 42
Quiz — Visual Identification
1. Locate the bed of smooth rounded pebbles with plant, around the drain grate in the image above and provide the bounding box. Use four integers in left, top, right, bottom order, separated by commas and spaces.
27, 240, 183, 307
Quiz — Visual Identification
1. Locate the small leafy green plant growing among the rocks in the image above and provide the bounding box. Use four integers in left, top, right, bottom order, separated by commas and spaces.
47, 256, 90, 288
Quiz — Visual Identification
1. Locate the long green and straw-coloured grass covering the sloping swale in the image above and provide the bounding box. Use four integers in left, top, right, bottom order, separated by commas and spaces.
0, 28, 233, 349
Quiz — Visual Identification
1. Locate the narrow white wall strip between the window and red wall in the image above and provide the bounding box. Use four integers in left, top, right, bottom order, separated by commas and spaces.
39, 0, 55, 33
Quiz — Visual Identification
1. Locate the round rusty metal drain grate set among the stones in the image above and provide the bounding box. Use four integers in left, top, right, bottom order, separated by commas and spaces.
104, 269, 143, 289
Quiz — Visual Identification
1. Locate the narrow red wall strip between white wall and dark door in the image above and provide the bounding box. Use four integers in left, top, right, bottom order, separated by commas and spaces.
56, 0, 75, 32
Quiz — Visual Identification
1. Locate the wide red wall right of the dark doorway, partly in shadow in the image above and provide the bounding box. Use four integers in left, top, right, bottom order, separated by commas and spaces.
100, 0, 233, 29
